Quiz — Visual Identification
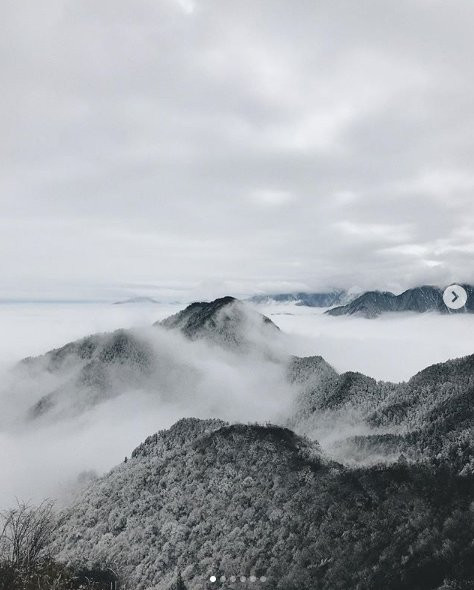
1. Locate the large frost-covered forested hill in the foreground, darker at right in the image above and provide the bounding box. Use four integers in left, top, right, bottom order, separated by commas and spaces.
52, 419, 474, 590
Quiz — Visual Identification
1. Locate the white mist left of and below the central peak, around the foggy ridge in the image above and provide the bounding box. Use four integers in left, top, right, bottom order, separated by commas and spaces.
0, 304, 292, 506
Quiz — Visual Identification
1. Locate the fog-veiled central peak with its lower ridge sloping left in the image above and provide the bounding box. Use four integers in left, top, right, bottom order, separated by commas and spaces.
18, 297, 280, 419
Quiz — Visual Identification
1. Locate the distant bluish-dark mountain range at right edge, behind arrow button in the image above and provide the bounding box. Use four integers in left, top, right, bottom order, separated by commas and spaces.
326, 285, 474, 318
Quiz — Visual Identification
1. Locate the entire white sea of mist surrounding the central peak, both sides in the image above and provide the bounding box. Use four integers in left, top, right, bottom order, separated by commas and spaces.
0, 304, 474, 507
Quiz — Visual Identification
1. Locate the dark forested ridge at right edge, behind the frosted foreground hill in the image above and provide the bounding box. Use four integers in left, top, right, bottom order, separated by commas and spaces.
288, 355, 474, 474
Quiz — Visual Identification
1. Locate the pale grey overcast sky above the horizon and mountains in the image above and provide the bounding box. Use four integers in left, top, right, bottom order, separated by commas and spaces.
0, 0, 474, 298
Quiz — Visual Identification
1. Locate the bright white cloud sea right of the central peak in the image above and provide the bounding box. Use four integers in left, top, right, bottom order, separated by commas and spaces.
261, 304, 474, 382
